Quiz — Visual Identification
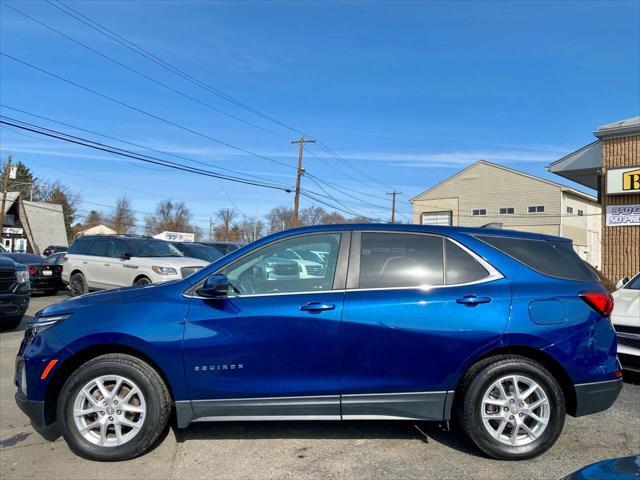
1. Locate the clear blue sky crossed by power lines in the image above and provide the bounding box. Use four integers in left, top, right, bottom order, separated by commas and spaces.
0, 0, 640, 227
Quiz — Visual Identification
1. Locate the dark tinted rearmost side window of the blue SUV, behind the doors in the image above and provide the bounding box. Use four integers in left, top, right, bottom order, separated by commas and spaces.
476, 235, 598, 282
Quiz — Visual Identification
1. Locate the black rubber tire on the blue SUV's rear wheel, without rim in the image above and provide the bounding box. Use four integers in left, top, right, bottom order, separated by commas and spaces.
457, 355, 566, 460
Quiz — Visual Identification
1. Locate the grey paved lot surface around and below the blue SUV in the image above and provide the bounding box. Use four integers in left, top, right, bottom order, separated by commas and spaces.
0, 294, 640, 480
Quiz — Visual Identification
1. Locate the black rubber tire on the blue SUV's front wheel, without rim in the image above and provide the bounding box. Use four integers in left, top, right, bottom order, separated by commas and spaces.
57, 354, 171, 461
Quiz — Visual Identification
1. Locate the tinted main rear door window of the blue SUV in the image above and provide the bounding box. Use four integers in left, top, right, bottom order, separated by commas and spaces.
359, 232, 444, 288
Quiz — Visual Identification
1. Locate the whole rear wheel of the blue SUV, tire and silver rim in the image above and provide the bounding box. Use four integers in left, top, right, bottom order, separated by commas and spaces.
458, 356, 566, 460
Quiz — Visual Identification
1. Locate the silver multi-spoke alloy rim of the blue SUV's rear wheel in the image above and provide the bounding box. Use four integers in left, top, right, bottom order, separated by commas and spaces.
481, 375, 551, 447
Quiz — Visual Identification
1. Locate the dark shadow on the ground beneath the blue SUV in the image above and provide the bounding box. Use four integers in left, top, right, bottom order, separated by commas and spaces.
172, 420, 484, 457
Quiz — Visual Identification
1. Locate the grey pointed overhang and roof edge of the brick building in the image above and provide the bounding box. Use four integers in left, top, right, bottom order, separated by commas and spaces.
546, 116, 640, 190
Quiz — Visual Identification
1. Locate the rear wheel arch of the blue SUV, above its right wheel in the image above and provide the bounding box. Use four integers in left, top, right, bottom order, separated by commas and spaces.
453, 345, 577, 416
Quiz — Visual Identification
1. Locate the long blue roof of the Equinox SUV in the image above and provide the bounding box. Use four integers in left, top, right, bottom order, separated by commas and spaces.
266, 223, 570, 241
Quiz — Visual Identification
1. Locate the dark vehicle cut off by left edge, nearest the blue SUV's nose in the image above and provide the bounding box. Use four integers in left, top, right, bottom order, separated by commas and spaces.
0, 255, 29, 329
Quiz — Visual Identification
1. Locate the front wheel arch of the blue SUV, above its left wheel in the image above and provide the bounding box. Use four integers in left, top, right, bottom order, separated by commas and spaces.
44, 344, 175, 424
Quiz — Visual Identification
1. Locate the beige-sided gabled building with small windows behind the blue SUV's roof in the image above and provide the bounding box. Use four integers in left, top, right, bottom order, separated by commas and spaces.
411, 160, 602, 267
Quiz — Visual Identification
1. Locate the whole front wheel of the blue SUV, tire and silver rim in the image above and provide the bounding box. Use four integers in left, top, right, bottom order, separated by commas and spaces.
57, 354, 171, 461
